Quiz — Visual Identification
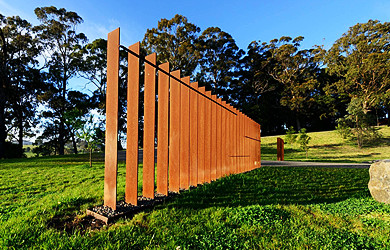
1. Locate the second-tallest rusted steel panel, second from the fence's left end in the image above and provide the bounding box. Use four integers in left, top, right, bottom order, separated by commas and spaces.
125, 42, 140, 206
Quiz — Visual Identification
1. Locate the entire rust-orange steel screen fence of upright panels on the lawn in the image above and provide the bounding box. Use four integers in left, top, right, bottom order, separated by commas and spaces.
104, 28, 260, 210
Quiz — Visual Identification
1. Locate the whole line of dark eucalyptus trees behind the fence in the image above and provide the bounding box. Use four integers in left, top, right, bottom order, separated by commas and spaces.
0, 6, 390, 158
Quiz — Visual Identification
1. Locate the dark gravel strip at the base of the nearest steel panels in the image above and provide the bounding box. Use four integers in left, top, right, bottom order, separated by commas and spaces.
90, 192, 177, 218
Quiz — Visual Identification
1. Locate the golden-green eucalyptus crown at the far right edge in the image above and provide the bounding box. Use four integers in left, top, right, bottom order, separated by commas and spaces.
325, 20, 390, 118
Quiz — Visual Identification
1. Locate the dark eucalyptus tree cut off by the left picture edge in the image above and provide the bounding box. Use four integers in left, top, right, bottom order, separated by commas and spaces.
0, 14, 42, 158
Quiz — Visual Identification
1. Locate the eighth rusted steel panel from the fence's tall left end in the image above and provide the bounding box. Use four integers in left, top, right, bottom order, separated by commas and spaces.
198, 87, 208, 184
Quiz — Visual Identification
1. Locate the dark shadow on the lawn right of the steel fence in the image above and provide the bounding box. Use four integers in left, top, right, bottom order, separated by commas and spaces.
167, 167, 369, 209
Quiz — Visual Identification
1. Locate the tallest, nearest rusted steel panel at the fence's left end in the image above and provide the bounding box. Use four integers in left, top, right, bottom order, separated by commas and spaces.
104, 28, 119, 210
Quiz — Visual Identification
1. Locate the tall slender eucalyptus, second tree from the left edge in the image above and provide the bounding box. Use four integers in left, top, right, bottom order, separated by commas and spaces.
35, 6, 87, 155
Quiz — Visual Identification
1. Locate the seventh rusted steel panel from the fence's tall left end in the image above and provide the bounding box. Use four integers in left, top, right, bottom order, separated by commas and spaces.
189, 82, 199, 186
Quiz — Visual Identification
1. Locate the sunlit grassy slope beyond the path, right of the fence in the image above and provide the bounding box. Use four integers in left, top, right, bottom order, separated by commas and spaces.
261, 126, 390, 162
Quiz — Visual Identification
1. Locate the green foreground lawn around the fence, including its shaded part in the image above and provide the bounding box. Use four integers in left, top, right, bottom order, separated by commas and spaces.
0, 152, 390, 249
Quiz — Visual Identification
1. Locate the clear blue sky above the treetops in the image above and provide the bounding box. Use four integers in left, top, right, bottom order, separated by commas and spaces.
0, 0, 390, 49
